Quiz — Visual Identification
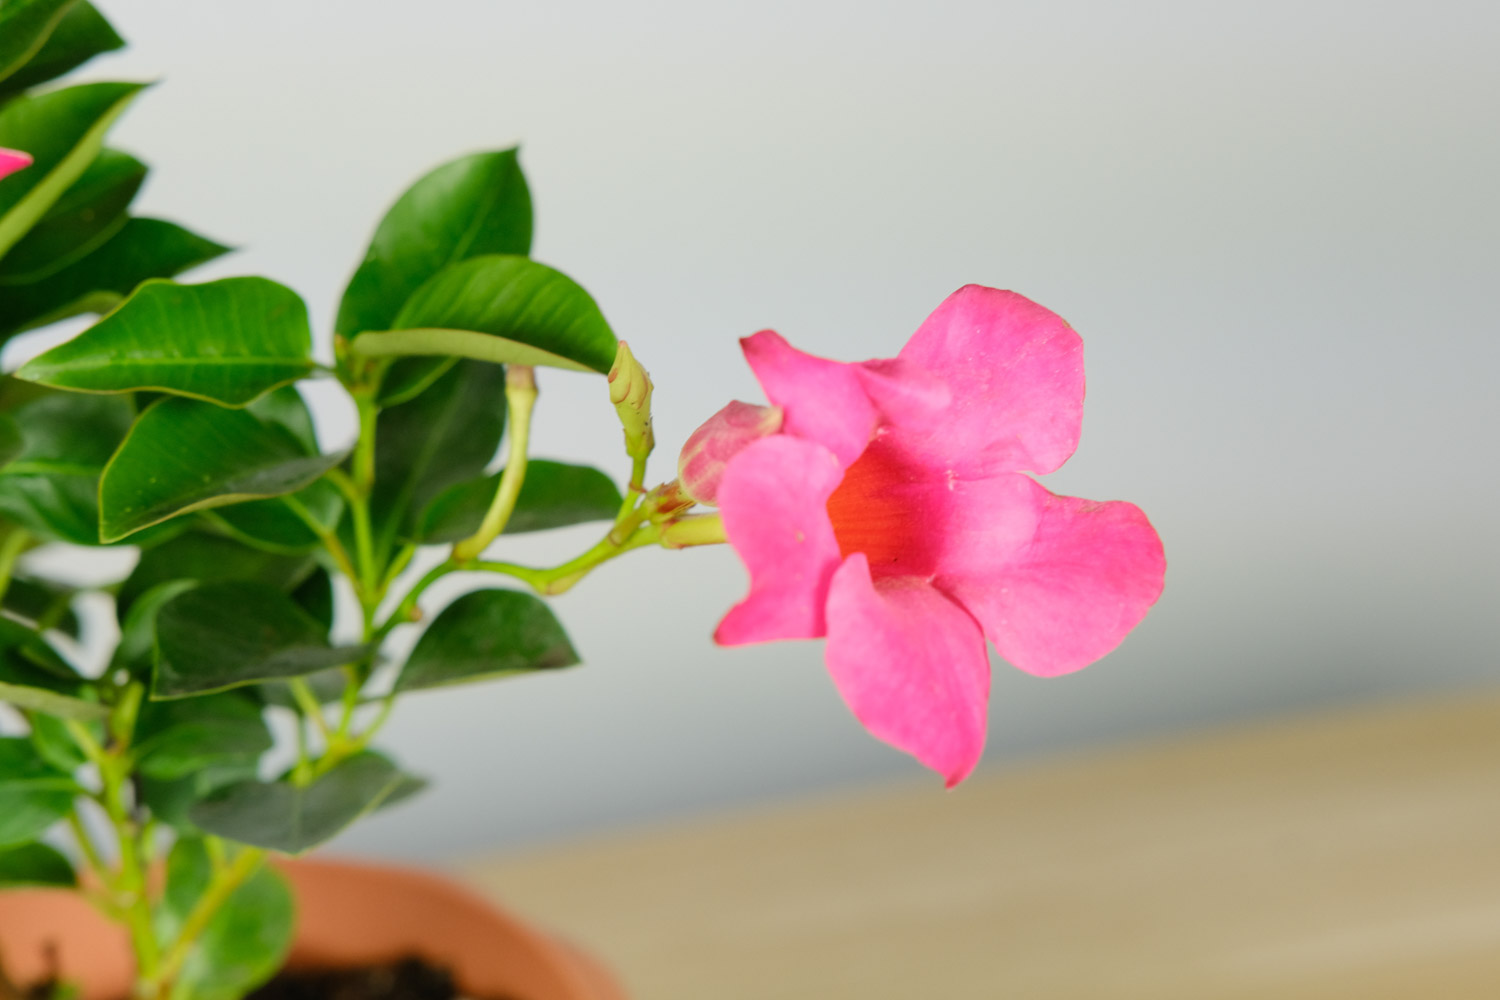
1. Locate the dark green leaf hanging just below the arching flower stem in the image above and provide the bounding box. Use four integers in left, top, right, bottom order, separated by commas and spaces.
396, 591, 578, 691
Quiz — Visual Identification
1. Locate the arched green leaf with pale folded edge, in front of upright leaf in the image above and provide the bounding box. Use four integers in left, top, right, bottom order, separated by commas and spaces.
353, 256, 620, 373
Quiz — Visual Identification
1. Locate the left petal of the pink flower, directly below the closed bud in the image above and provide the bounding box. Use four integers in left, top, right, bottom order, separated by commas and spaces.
714, 435, 843, 646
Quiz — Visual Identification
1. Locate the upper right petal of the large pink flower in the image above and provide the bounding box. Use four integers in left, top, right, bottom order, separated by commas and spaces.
897, 285, 1083, 477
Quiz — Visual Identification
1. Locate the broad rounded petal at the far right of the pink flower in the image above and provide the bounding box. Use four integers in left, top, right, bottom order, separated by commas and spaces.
935, 475, 1167, 676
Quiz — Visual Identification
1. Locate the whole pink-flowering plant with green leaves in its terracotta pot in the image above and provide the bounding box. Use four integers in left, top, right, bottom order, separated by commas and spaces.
0, 0, 1164, 1000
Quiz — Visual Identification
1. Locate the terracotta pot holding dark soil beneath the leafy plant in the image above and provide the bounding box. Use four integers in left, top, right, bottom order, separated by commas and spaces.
0, 861, 624, 1000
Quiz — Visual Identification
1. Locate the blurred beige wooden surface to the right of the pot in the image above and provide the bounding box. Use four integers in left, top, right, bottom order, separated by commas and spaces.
465, 694, 1500, 1000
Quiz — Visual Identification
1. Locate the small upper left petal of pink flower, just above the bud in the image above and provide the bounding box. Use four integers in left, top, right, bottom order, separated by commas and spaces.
740, 330, 878, 466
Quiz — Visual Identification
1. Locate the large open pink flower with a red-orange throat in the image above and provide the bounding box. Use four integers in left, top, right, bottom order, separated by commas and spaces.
699, 285, 1166, 787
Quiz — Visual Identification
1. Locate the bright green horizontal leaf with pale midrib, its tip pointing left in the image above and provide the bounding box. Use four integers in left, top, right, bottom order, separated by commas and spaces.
17, 277, 314, 406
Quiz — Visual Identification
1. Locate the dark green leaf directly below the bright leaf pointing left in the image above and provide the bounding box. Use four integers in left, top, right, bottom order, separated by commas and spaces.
99, 399, 344, 541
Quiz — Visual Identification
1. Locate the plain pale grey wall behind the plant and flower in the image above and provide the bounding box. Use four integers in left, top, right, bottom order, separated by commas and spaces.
5, 0, 1500, 859
